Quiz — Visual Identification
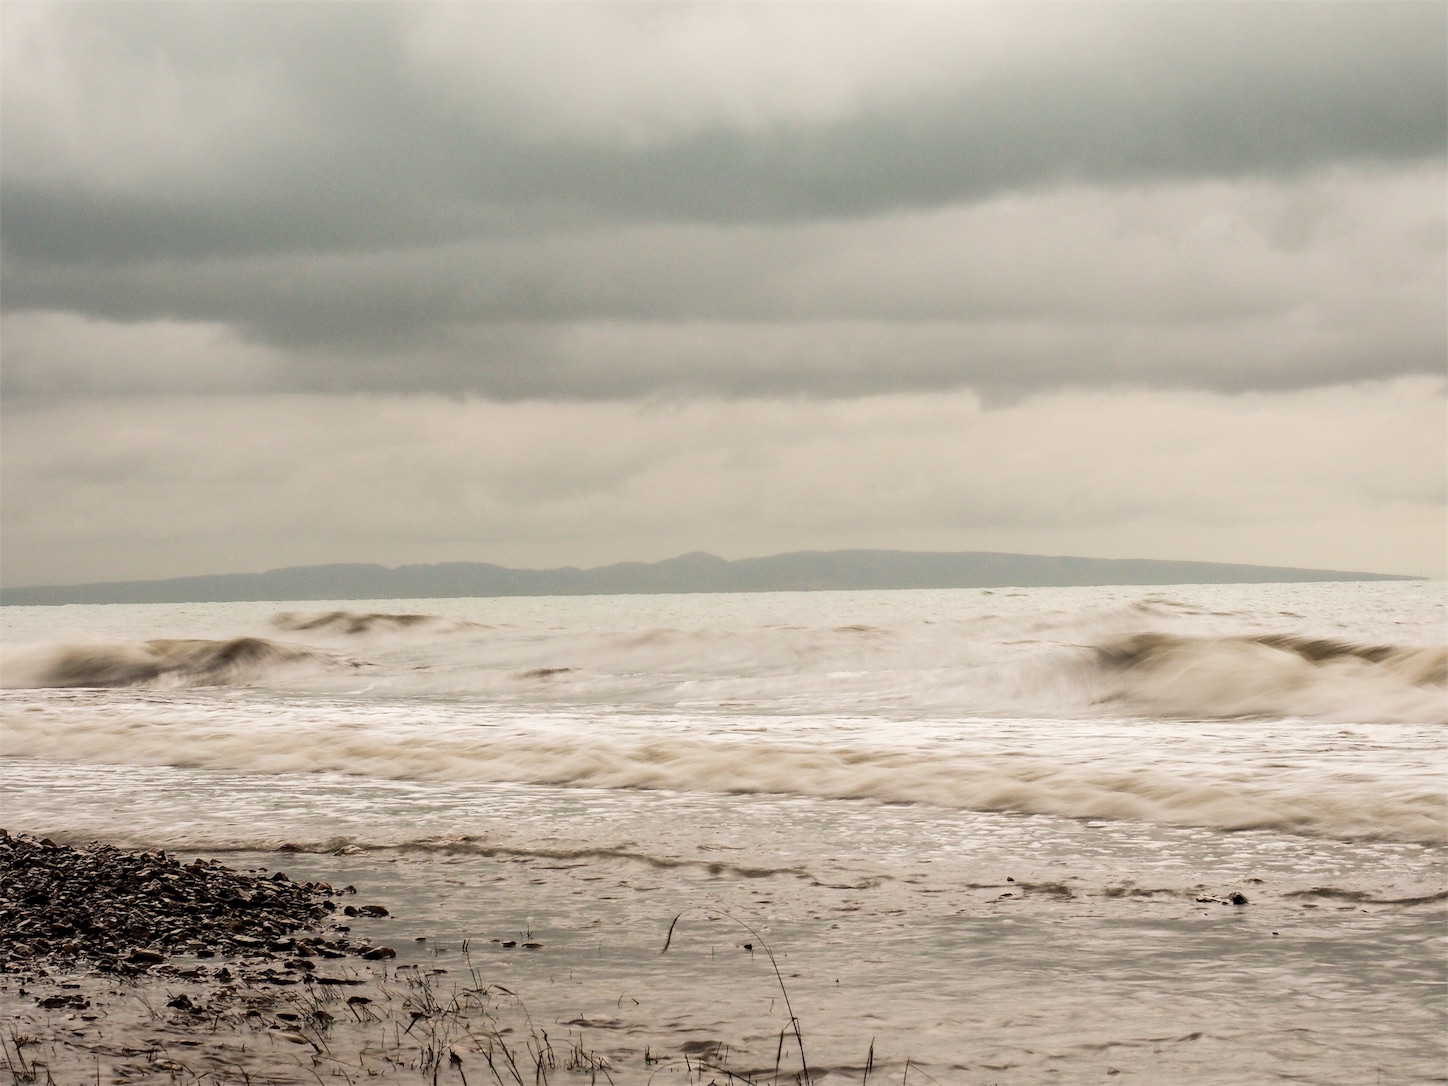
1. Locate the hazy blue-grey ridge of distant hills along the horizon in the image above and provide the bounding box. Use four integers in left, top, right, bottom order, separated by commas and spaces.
0, 550, 1420, 605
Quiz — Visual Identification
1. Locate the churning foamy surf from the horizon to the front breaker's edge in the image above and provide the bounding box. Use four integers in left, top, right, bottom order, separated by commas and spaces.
0, 585, 1448, 841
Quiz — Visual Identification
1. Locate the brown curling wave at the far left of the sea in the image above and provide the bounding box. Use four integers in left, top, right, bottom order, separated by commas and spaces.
4, 637, 358, 688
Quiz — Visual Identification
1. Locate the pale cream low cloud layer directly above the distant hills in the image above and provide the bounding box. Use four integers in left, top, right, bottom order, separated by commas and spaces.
3, 378, 1448, 584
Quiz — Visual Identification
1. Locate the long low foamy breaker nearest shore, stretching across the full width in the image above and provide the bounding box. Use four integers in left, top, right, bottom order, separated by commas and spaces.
6, 711, 1448, 844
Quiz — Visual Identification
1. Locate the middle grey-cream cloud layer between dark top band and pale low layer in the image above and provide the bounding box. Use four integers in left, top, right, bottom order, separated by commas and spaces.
3, 169, 1448, 400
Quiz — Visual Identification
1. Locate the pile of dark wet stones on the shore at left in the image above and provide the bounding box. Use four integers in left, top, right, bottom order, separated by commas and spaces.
0, 830, 392, 975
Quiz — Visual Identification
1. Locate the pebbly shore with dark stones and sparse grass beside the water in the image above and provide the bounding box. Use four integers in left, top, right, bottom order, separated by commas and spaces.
0, 830, 779, 1086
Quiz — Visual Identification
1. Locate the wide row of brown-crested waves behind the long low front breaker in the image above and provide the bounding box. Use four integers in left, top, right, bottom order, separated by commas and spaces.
4, 599, 1448, 724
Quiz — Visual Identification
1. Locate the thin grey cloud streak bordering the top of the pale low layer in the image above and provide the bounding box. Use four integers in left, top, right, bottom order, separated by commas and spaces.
4, 320, 1444, 403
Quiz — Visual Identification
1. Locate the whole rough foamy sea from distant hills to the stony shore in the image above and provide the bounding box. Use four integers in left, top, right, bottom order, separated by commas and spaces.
0, 582, 1448, 1086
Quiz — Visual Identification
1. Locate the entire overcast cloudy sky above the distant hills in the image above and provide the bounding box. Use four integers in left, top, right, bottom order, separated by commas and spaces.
0, 1, 1448, 586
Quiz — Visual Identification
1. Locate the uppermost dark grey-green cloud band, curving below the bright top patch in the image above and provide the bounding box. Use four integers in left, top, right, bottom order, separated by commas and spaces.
0, 4, 1448, 261
